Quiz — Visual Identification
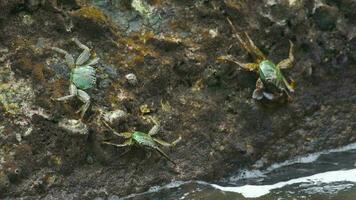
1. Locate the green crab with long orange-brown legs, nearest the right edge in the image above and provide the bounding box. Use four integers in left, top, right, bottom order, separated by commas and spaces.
218, 18, 294, 101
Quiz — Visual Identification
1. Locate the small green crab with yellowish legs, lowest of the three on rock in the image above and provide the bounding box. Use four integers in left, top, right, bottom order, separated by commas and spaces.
102, 121, 182, 165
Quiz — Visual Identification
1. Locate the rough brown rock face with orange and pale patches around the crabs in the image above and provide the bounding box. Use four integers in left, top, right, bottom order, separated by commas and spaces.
0, 0, 356, 199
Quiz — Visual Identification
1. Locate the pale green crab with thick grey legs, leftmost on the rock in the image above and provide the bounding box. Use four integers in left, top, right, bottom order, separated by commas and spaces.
51, 38, 99, 118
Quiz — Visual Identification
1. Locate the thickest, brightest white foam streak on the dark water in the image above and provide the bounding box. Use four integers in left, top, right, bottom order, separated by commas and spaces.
211, 169, 356, 198
